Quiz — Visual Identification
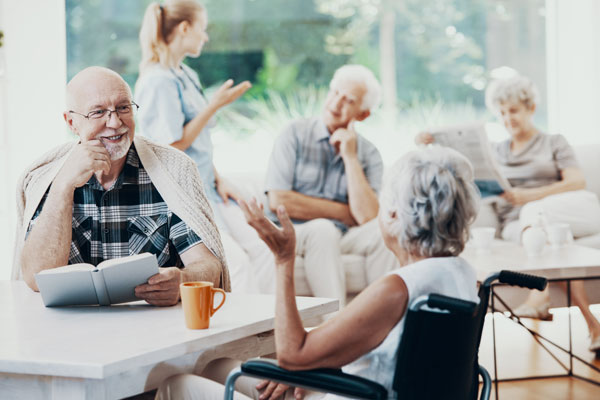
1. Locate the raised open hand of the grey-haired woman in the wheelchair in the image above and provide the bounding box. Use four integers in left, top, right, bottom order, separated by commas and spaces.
239, 198, 296, 264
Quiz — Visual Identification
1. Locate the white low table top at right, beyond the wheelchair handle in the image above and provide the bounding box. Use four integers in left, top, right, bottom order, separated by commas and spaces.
460, 240, 600, 281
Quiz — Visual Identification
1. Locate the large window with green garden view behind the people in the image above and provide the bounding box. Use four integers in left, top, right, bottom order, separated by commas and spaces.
66, 0, 547, 171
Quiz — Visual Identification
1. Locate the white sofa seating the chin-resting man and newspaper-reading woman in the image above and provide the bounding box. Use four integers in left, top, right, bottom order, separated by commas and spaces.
228, 144, 600, 302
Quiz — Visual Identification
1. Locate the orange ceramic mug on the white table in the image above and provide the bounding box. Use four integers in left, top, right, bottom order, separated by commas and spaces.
179, 282, 225, 329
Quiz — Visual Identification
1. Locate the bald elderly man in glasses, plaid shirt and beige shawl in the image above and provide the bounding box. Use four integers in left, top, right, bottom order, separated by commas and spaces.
14, 67, 230, 306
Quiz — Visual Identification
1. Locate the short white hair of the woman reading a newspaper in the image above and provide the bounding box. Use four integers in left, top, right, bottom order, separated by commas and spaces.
485, 75, 540, 114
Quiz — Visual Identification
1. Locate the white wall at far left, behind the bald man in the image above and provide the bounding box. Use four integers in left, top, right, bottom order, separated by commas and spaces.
0, 0, 67, 279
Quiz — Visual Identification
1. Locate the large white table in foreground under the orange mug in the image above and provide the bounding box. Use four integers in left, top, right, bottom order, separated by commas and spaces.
0, 281, 338, 399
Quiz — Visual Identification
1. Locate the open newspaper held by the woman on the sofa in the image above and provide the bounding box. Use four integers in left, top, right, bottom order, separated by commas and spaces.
429, 123, 511, 198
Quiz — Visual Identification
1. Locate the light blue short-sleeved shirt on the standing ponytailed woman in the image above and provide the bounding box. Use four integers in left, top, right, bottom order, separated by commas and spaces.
135, 64, 222, 208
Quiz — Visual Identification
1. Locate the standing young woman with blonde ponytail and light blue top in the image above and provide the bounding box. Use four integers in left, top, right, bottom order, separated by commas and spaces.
135, 0, 272, 290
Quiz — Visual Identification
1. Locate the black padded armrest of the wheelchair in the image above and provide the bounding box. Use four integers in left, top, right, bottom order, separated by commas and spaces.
241, 360, 387, 399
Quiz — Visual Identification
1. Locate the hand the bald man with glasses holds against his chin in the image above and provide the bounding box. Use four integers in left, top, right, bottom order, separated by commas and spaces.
54, 140, 110, 189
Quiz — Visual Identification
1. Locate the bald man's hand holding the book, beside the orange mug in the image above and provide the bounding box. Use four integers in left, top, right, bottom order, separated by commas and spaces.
135, 267, 181, 306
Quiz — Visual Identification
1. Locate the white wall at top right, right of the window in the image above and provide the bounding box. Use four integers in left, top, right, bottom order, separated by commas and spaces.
546, 0, 600, 144
